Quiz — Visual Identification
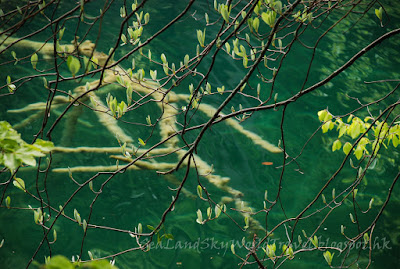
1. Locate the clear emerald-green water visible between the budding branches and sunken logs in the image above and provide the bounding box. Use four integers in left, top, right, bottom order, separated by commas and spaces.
0, 1, 400, 269
